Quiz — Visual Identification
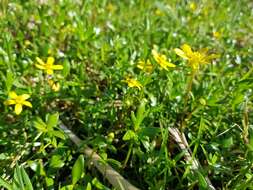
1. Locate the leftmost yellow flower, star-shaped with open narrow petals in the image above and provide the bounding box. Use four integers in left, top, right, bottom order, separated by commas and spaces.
4, 91, 32, 115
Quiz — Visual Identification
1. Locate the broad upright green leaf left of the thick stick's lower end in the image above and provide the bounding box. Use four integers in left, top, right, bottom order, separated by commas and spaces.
72, 154, 84, 184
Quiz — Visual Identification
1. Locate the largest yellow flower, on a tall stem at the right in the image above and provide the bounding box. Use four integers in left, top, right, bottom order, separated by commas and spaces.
174, 44, 219, 70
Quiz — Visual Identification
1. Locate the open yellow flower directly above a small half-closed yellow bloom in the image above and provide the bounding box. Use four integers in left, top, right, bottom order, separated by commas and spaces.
35, 57, 63, 75
